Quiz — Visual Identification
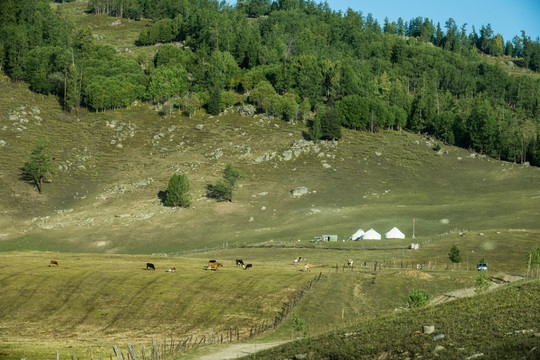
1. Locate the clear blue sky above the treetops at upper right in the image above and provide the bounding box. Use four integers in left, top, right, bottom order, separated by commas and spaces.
324, 0, 540, 42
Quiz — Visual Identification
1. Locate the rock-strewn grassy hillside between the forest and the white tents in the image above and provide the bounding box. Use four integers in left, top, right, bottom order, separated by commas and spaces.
0, 74, 540, 252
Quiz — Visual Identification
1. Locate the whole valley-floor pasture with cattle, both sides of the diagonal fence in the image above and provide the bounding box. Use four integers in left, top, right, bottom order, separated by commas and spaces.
0, 231, 540, 359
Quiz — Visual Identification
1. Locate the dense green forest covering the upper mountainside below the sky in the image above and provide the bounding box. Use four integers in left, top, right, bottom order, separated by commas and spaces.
0, 0, 540, 166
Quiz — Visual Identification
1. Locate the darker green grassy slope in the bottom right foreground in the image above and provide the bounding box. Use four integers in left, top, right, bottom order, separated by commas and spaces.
246, 280, 540, 359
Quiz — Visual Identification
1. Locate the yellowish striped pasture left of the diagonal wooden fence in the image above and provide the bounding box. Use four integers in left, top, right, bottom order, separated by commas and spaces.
0, 252, 312, 359
